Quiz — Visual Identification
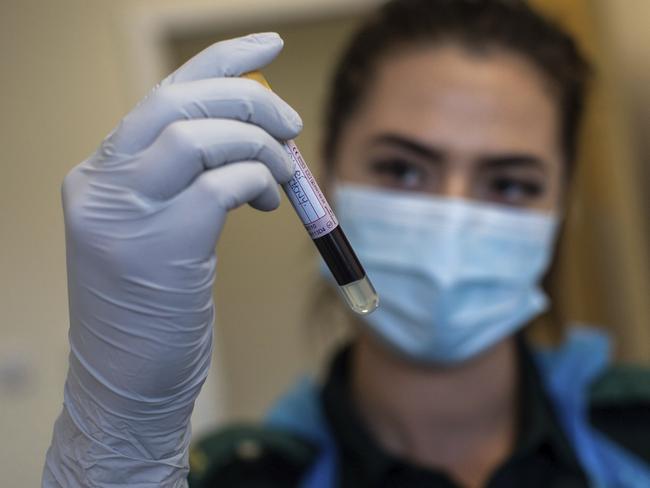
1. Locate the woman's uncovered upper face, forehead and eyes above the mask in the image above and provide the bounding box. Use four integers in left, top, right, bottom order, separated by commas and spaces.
334, 45, 563, 212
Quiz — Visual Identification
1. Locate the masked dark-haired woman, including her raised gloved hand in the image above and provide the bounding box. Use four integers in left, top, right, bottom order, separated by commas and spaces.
44, 0, 650, 488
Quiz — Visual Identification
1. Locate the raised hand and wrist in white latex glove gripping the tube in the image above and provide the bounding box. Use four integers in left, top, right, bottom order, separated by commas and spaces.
43, 34, 302, 488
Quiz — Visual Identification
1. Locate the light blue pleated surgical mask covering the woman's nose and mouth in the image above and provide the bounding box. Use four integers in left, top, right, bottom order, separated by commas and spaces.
326, 183, 558, 364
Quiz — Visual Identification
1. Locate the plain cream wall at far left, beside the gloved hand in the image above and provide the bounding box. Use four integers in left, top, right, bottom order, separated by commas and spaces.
0, 0, 125, 486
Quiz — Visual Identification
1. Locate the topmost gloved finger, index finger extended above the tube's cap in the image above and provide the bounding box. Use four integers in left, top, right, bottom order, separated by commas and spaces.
161, 32, 284, 85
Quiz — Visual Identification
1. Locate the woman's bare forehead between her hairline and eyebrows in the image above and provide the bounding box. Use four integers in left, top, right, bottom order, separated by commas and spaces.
357, 45, 560, 156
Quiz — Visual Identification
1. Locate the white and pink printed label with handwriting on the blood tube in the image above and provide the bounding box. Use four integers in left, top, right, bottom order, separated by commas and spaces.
282, 141, 339, 239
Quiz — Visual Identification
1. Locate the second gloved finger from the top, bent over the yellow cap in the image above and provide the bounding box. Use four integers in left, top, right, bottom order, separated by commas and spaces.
107, 78, 302, 154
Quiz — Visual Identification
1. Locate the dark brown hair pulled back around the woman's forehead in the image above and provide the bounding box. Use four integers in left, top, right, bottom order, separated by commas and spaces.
323, 0, 590, 165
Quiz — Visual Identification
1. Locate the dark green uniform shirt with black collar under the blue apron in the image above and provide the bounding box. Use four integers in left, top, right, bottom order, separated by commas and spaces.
190, 341, 650, 488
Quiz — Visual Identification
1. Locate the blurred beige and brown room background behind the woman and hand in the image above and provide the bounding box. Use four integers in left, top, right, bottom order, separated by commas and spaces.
0, 0, 650, 487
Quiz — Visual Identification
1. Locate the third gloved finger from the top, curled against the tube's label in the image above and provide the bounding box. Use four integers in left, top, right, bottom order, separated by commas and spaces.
124, 119, 293, 200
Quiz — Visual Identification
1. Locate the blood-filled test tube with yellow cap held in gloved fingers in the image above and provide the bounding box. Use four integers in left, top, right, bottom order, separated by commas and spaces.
242, 71, 379, 315
